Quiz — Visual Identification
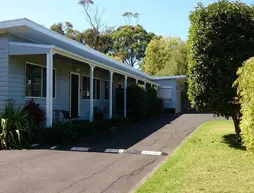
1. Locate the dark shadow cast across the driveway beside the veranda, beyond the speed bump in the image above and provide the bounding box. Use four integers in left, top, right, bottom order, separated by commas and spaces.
68, 114, 181, 150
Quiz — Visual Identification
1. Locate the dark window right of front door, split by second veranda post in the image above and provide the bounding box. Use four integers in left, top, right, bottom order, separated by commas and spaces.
82, 76, 101, 100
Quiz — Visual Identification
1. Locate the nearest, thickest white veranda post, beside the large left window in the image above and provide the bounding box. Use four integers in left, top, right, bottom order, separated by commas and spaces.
46, 50, 53, 127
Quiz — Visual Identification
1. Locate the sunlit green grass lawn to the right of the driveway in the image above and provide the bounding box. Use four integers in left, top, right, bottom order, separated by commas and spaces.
137, 120, 254, 193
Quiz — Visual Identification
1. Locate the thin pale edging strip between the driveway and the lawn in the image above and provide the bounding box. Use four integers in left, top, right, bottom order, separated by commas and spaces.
129, 121, 206, 193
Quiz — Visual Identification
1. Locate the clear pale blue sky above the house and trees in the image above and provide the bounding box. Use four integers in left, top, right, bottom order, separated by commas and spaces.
0, 0, 254, 40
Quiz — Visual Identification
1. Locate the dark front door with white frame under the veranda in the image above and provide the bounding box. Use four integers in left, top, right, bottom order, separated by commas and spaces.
70, 74, 79, 118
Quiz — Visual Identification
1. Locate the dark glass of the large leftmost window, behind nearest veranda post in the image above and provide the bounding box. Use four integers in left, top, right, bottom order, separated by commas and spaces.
25, 63, 56, 98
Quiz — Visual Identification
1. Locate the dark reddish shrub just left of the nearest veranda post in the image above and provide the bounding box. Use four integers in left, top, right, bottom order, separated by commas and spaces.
23, 99, 45, 141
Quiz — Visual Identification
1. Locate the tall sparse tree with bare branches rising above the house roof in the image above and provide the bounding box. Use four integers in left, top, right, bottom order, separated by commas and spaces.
79, 0, 106, 50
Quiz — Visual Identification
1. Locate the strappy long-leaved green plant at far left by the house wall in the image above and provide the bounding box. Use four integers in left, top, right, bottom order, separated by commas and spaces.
0, 100, 30, 149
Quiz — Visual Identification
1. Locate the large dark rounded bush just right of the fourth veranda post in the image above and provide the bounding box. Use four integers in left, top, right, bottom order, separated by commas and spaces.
127, 85, 148, 119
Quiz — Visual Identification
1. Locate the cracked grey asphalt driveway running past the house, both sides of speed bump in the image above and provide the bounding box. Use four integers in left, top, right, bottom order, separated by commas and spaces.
0, 114, 218, 193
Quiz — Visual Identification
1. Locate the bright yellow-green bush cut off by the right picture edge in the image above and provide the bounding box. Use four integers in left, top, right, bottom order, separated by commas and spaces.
235, 57, 254, 152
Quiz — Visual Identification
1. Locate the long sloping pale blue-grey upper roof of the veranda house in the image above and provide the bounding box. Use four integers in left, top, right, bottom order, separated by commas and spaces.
0, 18, 154, 81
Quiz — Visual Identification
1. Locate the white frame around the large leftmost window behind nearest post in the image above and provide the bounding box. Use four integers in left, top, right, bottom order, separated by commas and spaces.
24, 62, 57, 99
